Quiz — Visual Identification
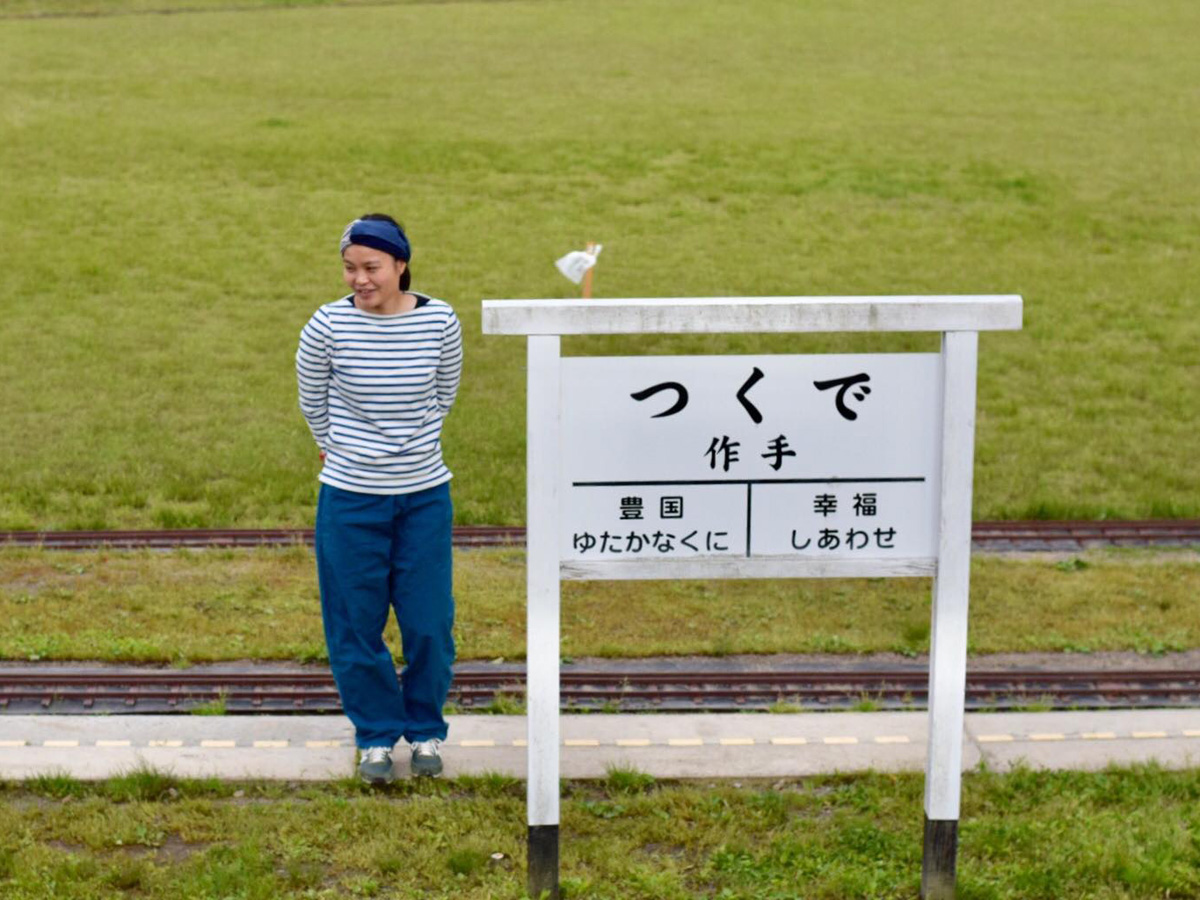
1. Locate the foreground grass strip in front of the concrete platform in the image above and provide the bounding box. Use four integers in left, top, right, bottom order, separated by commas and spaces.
0, 767, 1200, 900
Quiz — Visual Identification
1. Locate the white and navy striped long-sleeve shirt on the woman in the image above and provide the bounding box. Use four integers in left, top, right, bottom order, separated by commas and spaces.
296, 292, 462, 493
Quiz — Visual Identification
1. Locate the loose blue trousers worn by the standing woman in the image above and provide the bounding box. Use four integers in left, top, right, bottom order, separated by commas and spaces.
317, 484, 455, 749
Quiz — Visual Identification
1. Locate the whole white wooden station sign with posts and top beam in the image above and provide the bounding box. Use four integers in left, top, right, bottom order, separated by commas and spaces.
484, 296, 1021, 900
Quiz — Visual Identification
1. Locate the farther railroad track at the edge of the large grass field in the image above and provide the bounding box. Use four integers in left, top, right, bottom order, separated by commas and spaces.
0, 518, 1200, 551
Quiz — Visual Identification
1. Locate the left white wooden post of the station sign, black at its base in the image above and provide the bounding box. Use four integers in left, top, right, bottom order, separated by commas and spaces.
526, 335, 562, 900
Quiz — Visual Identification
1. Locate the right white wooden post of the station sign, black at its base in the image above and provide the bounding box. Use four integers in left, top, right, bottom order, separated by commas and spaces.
920, 331, 979, 900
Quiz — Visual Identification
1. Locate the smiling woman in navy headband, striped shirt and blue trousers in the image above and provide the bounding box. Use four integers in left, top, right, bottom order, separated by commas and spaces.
296, 214, 462, 784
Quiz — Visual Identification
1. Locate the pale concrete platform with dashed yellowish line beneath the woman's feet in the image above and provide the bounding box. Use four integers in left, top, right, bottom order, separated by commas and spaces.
0, 709, 1200, 781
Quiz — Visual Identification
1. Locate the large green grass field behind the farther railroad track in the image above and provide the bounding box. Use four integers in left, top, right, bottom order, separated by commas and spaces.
0, 0, 1200, 529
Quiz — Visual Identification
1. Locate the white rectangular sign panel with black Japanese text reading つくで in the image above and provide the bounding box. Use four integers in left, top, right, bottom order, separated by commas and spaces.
559, 353, 941, 566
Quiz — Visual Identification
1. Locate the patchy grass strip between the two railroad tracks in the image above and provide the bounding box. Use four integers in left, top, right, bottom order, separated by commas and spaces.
0, 548, 1200, 665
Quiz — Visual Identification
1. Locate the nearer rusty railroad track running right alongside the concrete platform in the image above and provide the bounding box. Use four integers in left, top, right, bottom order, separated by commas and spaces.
0, 666, 1200, 714
